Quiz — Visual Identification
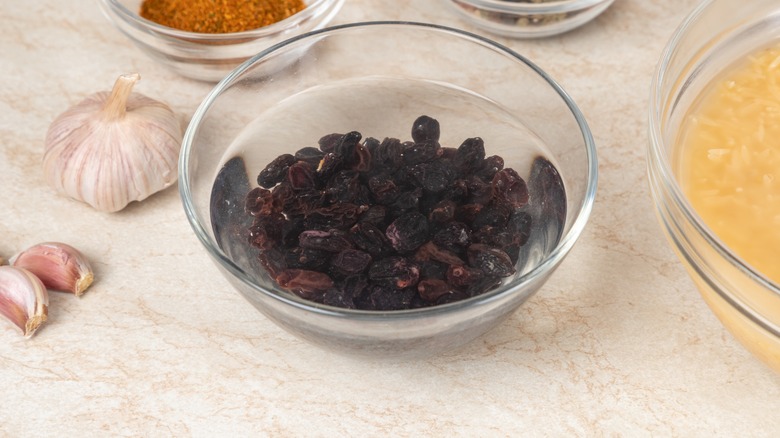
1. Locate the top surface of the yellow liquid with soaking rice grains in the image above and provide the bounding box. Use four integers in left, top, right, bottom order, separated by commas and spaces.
679, 48, 780, 283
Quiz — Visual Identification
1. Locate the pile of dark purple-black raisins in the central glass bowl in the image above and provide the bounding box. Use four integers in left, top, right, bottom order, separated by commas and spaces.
245, 116, 531, 310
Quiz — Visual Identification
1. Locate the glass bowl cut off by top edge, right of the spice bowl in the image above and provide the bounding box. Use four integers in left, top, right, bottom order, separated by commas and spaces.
444, 0, 615, 38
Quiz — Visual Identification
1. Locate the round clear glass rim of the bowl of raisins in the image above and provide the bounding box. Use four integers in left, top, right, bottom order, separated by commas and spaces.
178, 21, 598, 321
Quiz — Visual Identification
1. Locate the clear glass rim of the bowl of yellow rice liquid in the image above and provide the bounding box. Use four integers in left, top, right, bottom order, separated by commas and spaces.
647, 0, 780, 322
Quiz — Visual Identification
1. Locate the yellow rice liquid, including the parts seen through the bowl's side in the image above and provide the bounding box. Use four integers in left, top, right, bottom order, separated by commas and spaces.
675, 47, 780, 372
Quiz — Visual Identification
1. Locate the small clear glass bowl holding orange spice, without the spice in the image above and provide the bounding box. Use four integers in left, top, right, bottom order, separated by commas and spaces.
100, 0, 344, 82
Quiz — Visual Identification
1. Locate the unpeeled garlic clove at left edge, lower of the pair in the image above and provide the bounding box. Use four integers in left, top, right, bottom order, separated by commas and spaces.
0, 266, 49, 338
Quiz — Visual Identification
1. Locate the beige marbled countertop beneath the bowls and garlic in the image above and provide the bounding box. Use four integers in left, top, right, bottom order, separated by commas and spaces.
0, 0, 780, 437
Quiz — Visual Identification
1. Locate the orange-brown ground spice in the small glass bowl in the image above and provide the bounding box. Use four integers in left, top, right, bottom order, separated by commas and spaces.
140, 0, 306, 33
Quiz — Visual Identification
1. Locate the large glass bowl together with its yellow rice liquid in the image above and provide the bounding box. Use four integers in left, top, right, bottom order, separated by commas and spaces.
648, 0, 780, 370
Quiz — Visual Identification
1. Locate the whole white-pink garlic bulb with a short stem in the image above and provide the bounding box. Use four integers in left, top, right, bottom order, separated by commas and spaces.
43, 74, 182, 212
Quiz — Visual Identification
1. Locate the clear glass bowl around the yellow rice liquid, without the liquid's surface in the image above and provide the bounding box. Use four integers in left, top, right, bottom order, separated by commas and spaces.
647, 0, 780, 371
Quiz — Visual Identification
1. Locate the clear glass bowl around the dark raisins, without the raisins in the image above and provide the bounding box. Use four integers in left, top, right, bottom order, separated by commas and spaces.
179, 22, 597, 359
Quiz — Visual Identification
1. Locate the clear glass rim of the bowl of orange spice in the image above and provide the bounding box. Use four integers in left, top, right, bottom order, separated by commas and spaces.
100, 0, 338, 42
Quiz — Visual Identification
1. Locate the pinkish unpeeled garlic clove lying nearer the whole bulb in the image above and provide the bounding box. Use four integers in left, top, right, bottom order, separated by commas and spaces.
10, 242, 95, 296
